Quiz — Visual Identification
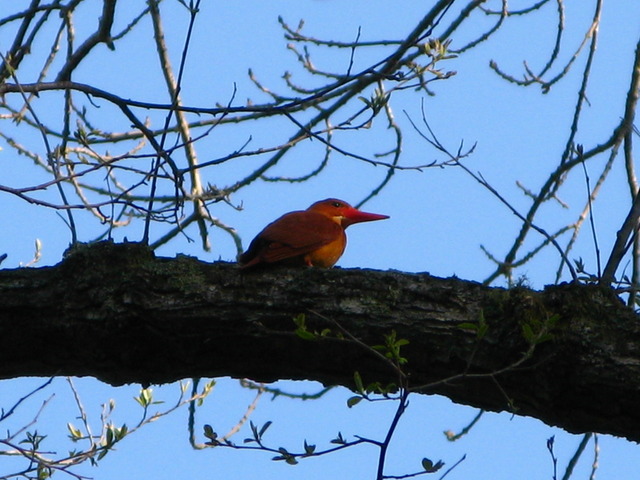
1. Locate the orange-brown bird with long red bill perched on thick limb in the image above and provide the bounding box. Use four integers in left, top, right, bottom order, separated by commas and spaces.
238, 198, 389, 268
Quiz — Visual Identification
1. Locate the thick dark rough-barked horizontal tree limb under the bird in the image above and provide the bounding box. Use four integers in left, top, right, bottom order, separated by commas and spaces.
0, 243, 640, 441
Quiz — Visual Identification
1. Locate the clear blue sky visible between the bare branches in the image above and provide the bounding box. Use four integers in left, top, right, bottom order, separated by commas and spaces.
0, 0, 640, 480
